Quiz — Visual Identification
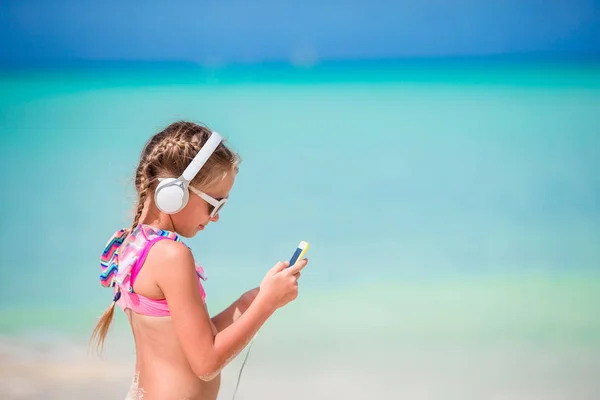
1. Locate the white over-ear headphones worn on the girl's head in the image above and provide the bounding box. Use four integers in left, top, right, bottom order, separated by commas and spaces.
154, 132, 223, 214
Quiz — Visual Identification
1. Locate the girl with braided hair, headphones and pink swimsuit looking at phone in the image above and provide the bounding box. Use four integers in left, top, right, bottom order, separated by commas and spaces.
92, 122, 308, 400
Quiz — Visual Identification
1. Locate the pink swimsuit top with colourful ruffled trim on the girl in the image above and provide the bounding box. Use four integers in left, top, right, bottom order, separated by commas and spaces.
100, 224, 206, 317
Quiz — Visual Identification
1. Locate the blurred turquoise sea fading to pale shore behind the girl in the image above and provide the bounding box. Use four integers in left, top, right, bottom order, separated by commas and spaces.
0, 60, 600, 400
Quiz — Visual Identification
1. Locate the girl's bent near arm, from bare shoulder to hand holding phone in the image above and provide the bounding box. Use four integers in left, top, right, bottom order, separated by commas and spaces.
144, 240, 308, 380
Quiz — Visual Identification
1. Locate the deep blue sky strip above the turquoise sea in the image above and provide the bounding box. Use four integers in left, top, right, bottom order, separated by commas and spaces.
0, 0, 600, 65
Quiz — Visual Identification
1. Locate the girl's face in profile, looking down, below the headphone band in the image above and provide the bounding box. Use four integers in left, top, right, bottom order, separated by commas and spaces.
171, 172, 235, 238
